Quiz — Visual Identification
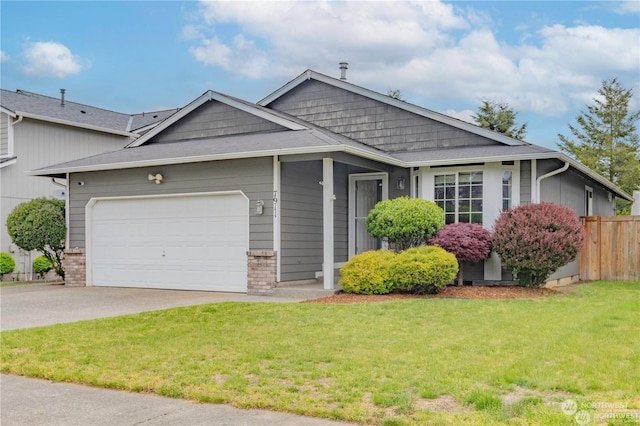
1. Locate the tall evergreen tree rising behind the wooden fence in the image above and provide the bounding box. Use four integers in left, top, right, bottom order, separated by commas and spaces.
558, 78, 640, 214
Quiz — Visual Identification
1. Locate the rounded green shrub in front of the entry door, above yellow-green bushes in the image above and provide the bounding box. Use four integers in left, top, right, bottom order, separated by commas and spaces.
366, 197, 444, 252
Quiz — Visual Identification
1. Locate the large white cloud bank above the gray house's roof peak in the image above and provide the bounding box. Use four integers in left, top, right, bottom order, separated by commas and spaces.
184, 1, 640, 119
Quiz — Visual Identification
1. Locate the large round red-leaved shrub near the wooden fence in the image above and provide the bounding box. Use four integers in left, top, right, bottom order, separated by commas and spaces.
493, 202, 585, 287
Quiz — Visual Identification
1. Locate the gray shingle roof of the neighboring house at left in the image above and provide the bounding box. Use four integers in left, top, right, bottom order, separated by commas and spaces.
0, 89, 177, 132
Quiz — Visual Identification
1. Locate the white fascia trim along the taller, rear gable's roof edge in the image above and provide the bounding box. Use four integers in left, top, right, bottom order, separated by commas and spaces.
258, 70, 528, 146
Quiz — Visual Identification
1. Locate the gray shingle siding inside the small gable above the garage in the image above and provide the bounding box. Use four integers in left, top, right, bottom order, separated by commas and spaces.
149, 101, 284, 143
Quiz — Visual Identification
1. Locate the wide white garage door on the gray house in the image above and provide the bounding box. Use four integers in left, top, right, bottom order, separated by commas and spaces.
87, 192, 249, 292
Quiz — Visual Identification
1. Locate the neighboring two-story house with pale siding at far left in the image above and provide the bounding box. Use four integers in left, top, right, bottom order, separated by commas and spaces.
0, 90, 176, 278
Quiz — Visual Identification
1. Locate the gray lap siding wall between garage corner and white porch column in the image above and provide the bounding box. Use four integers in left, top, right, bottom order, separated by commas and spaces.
280, 161, 323, 281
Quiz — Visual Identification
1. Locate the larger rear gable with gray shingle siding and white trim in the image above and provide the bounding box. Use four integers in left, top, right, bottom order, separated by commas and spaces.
258, 70, 527, 151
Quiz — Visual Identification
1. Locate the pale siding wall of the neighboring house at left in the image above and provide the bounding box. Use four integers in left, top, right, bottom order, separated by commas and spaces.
0, 118, 129, 272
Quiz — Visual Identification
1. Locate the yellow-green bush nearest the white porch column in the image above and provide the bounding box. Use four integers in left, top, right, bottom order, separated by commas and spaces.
338, 250, 395, 294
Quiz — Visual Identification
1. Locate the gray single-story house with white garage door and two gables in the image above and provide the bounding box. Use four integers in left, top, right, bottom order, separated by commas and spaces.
26, 71, 631, 294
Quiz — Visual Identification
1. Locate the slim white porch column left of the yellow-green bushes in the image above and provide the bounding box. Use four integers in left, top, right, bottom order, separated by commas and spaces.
322, 158, 335, 290
